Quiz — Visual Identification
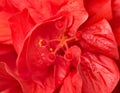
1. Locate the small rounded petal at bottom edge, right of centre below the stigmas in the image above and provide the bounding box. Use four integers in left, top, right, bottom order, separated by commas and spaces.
60, 72, 82, 93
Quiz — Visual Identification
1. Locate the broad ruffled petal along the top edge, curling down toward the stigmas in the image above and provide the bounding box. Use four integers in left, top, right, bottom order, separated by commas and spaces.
8, 0, 88, 35
